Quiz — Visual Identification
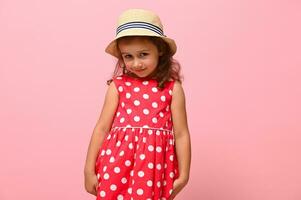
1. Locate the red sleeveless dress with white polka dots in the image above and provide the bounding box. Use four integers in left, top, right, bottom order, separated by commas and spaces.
95, 75, 179, 200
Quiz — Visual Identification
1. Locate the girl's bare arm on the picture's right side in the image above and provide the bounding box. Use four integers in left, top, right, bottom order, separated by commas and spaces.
171, 81, 191, 185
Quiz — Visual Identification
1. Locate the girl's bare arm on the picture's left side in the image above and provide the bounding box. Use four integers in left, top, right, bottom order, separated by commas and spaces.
84, 82, 119, 195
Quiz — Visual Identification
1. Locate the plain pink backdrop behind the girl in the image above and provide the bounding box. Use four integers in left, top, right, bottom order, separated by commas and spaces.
0, 0, 301, 200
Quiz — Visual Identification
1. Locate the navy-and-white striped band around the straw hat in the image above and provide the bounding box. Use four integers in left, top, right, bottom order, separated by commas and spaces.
116, 22, 164, 36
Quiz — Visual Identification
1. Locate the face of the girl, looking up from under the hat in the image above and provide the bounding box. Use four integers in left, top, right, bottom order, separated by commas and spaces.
118, 37, 160, 78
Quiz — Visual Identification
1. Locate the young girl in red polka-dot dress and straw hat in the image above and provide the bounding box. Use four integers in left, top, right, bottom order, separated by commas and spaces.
85, 9, 191, 200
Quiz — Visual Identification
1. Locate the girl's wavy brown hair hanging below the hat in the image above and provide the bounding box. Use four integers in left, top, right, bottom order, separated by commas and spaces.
107, 36, 182, 89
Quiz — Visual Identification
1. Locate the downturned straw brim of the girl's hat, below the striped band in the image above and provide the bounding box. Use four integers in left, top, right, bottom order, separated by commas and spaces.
105, 29, 177, 58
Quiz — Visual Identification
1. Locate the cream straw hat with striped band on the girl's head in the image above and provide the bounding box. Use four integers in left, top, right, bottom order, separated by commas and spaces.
105, 9, 177, 58
